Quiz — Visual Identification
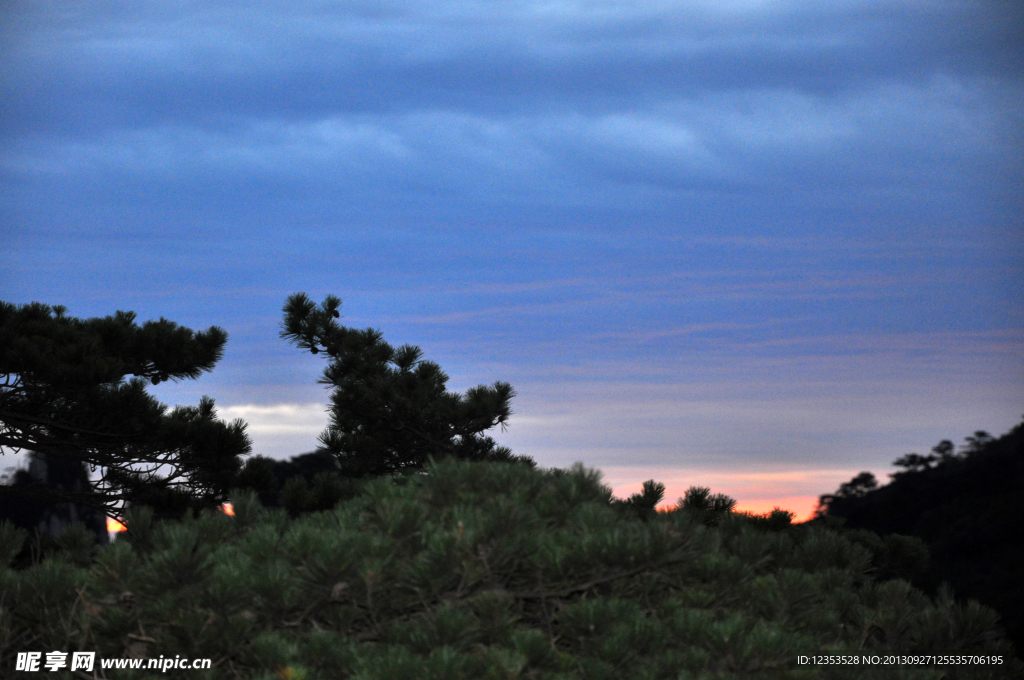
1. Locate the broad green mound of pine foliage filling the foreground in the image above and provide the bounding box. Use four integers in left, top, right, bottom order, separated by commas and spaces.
0, 459, 1024, 680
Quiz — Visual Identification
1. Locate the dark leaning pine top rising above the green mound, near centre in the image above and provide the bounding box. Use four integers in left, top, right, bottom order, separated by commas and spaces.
281, 293, 528, 477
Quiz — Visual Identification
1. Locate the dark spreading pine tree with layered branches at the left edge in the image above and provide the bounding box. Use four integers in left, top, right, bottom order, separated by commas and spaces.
0, 302, 250, 512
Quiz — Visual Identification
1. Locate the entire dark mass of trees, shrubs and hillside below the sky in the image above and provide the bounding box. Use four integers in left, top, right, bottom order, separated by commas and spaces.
0, 294, 1024, 680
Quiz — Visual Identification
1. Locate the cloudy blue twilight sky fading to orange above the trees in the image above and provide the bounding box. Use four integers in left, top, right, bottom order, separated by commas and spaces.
0, 0, 1024, 517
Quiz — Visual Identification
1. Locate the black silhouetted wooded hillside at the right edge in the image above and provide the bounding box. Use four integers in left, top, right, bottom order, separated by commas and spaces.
822, 423, 1024, 650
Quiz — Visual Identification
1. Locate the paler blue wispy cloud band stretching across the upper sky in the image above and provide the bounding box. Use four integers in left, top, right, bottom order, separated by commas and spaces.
3, 78, 1021, 212
